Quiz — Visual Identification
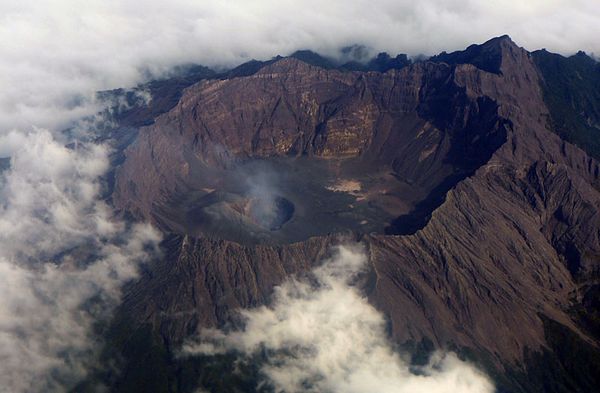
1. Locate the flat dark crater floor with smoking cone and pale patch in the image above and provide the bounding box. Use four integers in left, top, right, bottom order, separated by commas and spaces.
157, 157, 425, 244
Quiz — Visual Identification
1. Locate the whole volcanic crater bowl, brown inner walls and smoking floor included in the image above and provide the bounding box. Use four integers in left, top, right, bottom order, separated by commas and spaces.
114, 58, 510, 244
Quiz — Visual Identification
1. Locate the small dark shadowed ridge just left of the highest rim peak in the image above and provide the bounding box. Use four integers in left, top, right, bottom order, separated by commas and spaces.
429, 35, 515, 74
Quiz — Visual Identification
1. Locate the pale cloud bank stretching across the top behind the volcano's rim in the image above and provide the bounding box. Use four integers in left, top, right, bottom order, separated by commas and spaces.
0, 0, 600, 133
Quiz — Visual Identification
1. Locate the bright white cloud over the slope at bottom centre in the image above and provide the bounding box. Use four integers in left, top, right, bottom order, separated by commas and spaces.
182, 247, 494, 393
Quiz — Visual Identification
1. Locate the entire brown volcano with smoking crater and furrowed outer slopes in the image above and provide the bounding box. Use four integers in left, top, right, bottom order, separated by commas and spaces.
82, 36, 600, 392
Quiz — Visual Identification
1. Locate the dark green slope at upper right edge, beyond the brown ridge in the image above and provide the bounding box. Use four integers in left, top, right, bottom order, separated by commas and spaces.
532, 49, 600, 159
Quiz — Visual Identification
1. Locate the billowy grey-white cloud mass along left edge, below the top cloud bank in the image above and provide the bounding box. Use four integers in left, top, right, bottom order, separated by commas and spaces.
0, 129, 160, 392
